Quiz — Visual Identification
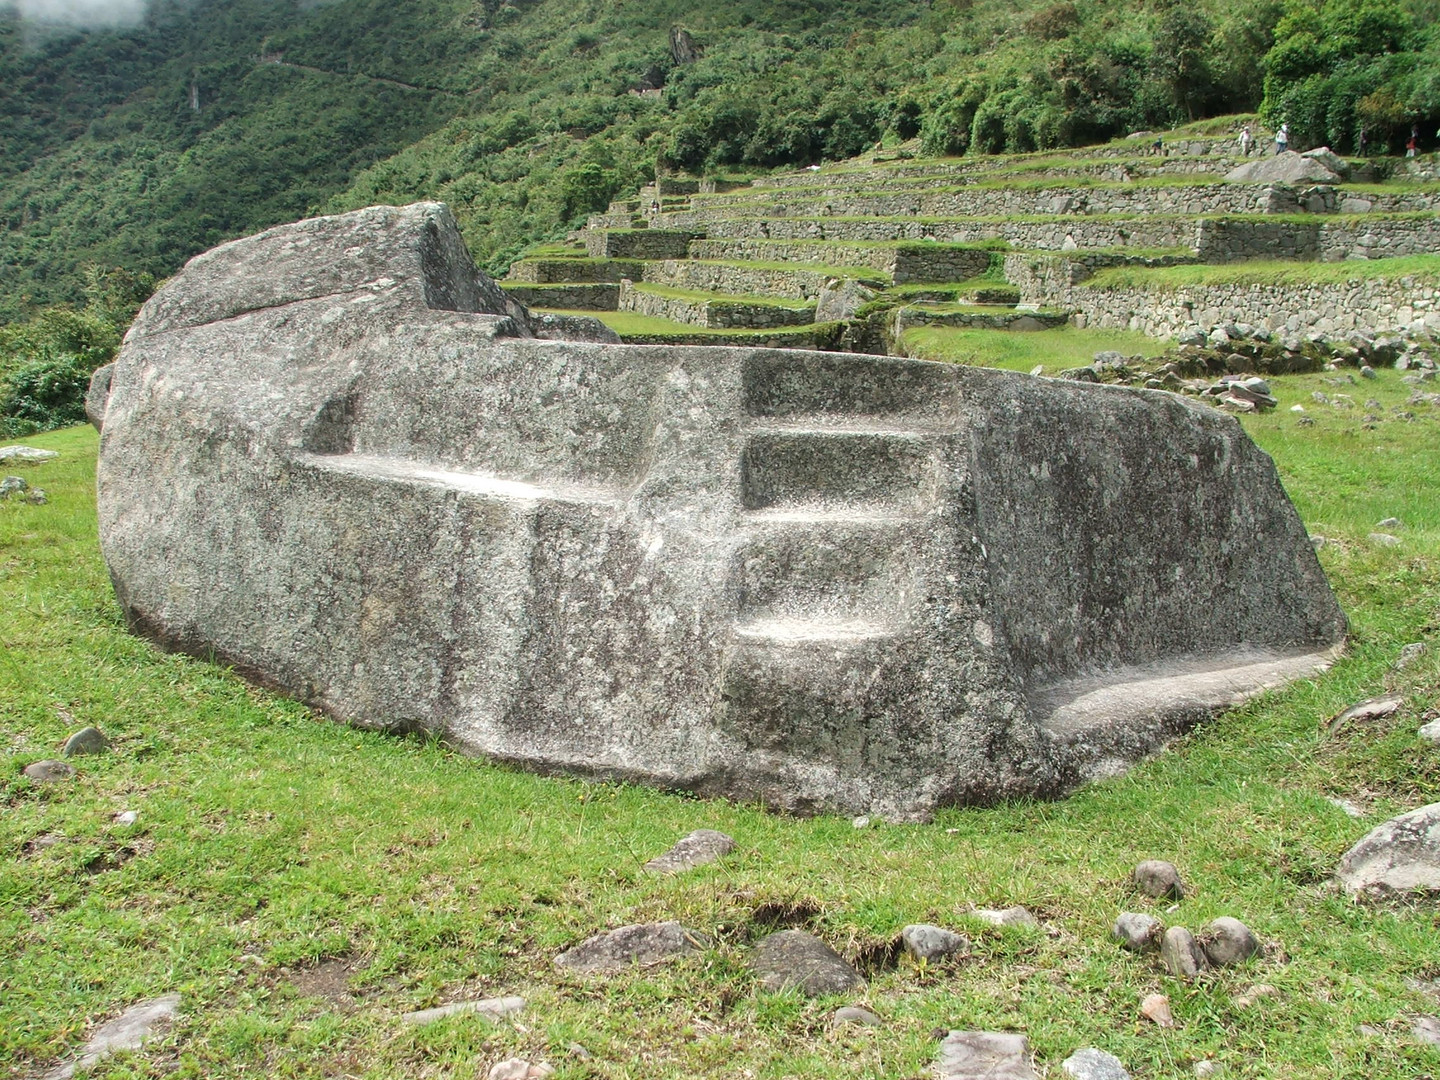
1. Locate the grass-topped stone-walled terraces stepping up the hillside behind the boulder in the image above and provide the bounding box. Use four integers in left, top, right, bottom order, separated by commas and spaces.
505, 135, 1440, 353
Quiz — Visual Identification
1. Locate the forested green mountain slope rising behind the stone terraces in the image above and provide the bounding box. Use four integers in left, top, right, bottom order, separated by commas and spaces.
0, 0, 1440, 323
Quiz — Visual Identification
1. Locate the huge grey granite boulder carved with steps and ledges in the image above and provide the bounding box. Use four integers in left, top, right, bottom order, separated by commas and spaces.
91, 203, 1345, 819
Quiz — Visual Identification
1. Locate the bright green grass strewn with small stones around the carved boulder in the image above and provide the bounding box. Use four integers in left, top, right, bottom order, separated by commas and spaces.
0, 368, 1440, 1080
